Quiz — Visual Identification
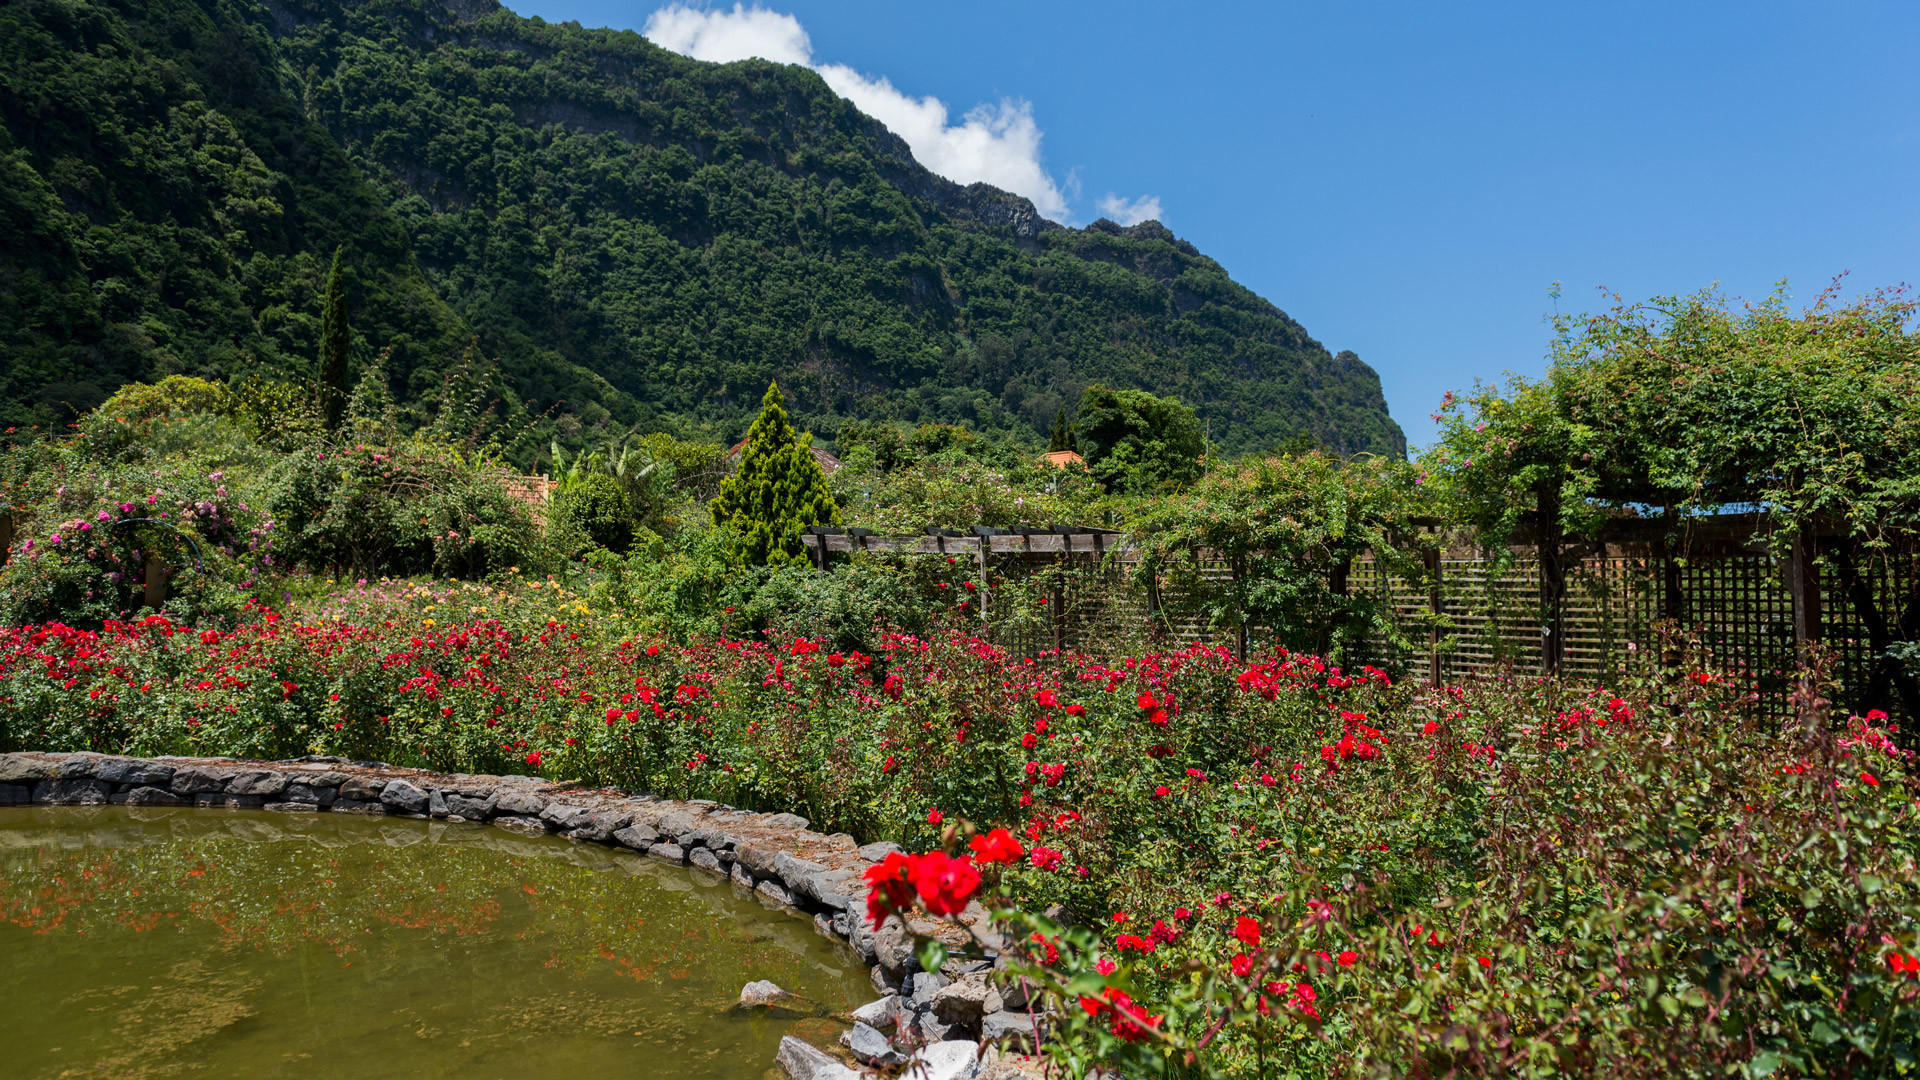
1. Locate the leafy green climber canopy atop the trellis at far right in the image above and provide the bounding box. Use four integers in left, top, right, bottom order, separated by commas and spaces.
1427, 286, 1920, 534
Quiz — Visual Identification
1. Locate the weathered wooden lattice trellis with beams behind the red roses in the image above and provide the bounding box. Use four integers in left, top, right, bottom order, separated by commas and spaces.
806, 515, 1920, 717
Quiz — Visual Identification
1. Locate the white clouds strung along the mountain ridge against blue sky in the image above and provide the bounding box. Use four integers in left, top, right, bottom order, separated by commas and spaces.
641, 4, 1160, 225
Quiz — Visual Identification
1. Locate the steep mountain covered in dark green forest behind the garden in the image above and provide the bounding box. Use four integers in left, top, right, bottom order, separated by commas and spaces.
0, 0, 1405, 454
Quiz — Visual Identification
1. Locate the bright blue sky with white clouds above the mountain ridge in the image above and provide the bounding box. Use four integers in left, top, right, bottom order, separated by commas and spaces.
509, 0, 1920, 444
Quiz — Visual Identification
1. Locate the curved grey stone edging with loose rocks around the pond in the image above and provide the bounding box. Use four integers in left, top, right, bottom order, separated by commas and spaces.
0, 751, 1035, 1080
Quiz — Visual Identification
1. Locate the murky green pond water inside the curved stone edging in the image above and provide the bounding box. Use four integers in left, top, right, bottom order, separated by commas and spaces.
0, 807, 872, 1080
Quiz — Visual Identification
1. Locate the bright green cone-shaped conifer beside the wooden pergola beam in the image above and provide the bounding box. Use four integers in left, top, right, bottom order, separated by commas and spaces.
712, 382, 839, 567
